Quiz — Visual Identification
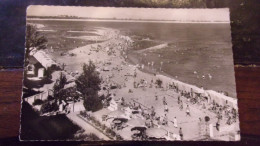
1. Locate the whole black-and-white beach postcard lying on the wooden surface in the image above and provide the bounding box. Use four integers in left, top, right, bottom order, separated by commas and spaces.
20, 5, 240, 141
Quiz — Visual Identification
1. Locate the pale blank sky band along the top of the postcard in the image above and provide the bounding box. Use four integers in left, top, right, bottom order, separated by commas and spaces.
27, 5, 230, 22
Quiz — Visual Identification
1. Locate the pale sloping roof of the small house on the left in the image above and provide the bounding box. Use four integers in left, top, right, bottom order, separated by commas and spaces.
33, 51, 58, 69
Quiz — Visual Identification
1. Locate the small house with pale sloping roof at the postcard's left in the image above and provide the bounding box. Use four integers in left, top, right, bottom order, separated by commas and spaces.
26, 51, 60, 79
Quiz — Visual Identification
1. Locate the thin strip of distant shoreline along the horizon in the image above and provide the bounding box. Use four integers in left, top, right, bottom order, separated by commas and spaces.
26, 18, 230, 24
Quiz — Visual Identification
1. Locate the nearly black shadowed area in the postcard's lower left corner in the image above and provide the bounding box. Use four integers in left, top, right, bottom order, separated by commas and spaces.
20, 102, 80, 140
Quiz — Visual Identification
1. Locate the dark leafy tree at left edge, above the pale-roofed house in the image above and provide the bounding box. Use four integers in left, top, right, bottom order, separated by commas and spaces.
25, 24, 48, 64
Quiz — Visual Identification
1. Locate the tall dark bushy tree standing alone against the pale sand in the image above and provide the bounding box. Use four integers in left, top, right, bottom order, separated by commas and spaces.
75, 61, 103, 112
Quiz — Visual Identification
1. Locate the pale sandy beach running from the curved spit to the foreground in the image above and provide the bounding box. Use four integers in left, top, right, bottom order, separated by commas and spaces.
44, 28, 238, 140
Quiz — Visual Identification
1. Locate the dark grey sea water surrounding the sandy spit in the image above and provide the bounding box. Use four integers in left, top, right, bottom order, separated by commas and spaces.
28, 20, 236, 98
